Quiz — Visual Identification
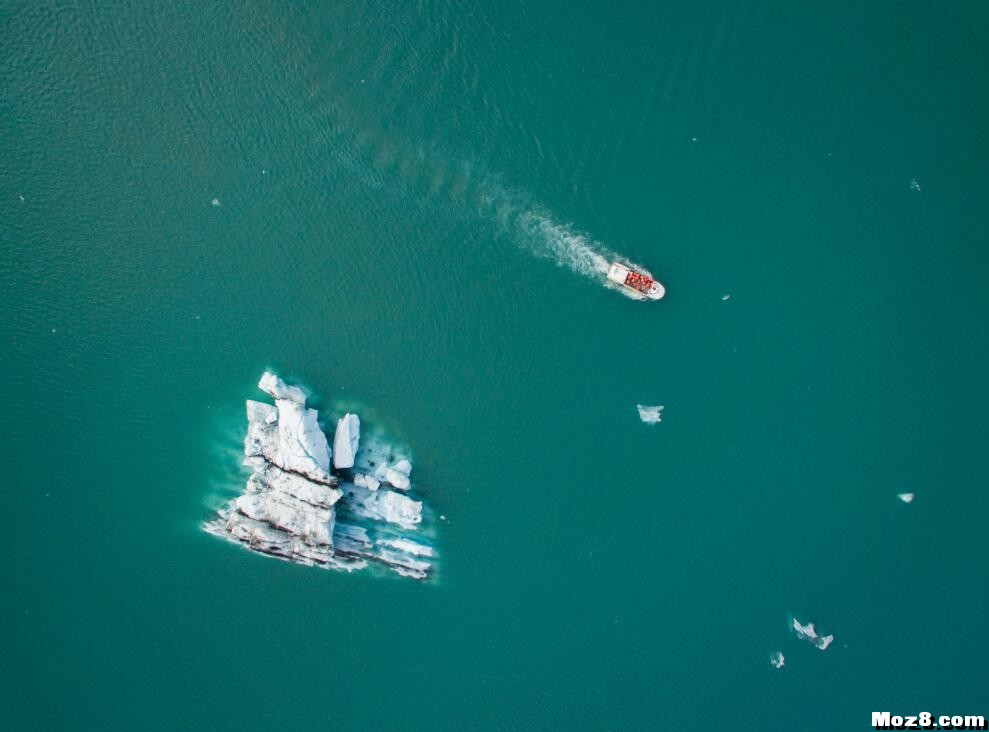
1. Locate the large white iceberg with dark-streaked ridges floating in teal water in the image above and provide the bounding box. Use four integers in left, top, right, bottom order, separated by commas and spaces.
203, 372, 435, 579
